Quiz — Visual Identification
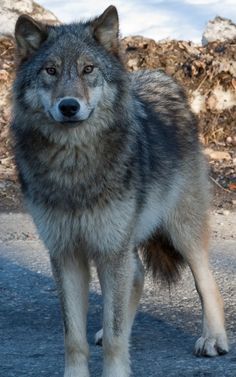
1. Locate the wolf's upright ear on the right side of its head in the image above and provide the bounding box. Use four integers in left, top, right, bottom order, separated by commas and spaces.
91, 5, 119, 53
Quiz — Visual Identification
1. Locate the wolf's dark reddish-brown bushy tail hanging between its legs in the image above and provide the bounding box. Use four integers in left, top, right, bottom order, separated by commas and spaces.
140, 232, 186, 286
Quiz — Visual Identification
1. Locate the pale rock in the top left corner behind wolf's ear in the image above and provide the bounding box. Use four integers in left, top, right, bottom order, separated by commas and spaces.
0, 0, 58, 36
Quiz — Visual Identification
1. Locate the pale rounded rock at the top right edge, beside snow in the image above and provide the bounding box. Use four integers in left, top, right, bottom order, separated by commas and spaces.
202, 17, 236, 46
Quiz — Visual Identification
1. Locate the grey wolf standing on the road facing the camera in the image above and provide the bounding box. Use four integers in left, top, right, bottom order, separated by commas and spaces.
11, 6, 228, 377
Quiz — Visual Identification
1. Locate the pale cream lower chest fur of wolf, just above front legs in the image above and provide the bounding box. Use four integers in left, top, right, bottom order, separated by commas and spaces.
29, 194, 135, 254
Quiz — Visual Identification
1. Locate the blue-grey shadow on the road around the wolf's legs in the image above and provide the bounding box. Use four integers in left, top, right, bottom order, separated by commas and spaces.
0, 248, 236, 377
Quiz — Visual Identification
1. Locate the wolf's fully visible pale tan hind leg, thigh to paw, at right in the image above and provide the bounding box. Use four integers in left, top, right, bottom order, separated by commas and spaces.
169, 212, 228, 356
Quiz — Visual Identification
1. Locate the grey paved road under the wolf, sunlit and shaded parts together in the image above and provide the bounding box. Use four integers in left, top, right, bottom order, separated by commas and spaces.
0, 213, 236, 377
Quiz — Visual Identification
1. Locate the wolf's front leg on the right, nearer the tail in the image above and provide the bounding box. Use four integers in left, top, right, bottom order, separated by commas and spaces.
97, 252, 135, 377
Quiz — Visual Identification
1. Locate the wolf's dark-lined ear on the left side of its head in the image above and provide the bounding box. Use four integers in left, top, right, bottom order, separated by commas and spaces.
15, 15, 47, 60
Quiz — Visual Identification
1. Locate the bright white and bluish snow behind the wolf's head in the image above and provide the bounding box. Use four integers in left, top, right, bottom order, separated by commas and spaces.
38, 0, 236, 43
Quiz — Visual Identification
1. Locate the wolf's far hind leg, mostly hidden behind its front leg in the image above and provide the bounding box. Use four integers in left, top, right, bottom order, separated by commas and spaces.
95, 253, 144, 346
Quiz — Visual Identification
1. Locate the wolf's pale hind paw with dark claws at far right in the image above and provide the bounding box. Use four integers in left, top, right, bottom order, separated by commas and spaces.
194, 335, 229, 357
